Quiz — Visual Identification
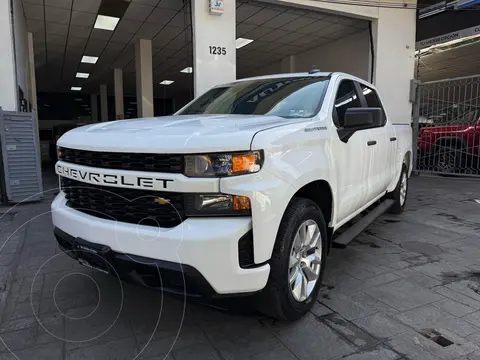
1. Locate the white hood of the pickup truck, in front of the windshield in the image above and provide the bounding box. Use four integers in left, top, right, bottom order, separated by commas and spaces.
57, 115, 296, 153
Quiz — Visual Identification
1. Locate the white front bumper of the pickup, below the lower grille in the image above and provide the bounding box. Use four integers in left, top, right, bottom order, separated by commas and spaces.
52, 192, 270, 296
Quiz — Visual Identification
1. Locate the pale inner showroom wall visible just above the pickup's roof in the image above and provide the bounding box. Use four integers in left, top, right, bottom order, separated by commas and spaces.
252, 30, 371, 81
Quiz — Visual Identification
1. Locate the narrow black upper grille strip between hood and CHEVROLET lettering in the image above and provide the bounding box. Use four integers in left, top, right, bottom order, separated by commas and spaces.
59, 148, 183, 174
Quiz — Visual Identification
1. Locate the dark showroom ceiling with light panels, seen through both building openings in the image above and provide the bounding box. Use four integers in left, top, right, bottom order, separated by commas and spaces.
23, 0, 368, 97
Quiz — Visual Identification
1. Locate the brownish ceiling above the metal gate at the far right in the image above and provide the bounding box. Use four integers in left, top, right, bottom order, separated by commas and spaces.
417, 41, 480, 81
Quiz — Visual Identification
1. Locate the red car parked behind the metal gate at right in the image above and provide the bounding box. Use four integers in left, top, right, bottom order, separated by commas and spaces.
418, 111, 480, 174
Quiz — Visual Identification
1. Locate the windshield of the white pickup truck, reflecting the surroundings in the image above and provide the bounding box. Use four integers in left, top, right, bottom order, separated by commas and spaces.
179, 76, 330, 118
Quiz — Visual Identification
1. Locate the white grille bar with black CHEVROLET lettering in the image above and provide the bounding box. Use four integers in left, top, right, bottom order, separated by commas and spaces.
55, 163, 173, 190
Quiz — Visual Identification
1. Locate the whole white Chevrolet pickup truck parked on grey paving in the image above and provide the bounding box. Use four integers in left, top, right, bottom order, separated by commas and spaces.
52, 71, 412, 320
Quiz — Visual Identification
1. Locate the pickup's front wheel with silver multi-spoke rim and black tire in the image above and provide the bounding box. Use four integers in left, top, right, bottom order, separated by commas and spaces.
259, 198, 327, 320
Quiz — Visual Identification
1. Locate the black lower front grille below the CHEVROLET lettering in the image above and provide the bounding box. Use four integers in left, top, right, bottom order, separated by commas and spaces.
61, 177, 186, 228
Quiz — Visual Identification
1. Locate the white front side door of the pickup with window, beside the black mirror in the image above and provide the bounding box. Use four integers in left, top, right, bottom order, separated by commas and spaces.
332, 79, 370, 223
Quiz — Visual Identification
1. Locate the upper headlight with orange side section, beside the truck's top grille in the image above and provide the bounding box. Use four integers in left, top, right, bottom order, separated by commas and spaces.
185, 151, 262, 177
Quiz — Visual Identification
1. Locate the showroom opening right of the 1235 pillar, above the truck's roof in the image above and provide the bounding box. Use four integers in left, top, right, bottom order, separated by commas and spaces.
236, 1, 373, 81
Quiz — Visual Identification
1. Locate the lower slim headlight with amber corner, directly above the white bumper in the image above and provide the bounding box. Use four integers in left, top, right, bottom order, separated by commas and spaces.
185, 194, 251, 216
